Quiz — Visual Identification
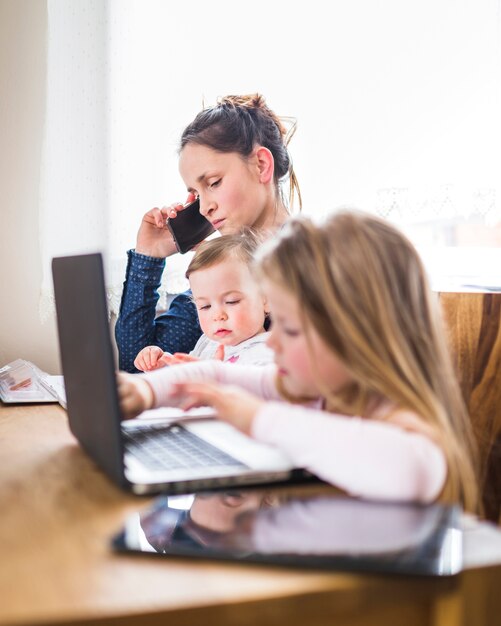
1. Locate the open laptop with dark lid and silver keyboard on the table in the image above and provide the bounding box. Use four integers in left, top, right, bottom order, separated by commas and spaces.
52, 253, 304, 494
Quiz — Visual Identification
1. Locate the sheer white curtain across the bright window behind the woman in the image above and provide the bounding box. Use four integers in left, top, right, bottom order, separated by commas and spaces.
41, 0, 501, 322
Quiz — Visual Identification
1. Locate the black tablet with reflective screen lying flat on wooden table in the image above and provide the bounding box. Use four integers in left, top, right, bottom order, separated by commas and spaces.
113, 489, 462, 576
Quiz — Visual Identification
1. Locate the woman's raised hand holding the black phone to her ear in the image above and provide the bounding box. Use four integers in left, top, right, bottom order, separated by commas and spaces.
136, 193, 195, 259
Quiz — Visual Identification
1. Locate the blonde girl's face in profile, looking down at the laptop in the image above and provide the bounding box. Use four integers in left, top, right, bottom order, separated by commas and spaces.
264, 281, 353, 398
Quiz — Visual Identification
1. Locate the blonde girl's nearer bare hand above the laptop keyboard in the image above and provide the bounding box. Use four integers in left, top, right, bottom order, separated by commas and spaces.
171, 383, 264, 435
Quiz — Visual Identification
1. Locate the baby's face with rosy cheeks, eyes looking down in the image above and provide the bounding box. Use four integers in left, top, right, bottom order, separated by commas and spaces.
190, 257, 265, 346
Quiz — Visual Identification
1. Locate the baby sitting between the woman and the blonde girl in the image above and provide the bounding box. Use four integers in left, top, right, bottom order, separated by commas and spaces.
134, 230, 273, 372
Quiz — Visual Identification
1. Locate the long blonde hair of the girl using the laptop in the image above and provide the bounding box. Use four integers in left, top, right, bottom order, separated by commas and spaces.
257, 211, 478, 511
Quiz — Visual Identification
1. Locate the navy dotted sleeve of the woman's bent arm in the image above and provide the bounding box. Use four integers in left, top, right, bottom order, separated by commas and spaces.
115, 250, 202, 372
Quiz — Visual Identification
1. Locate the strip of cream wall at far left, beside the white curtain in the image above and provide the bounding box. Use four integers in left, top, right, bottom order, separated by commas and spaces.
0, 0, 59, 373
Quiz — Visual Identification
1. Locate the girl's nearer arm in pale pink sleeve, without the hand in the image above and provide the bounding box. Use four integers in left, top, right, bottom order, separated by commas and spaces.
251, 403, 447, 502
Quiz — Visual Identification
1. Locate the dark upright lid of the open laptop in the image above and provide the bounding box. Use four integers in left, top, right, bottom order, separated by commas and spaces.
52, 253, 128, 486
